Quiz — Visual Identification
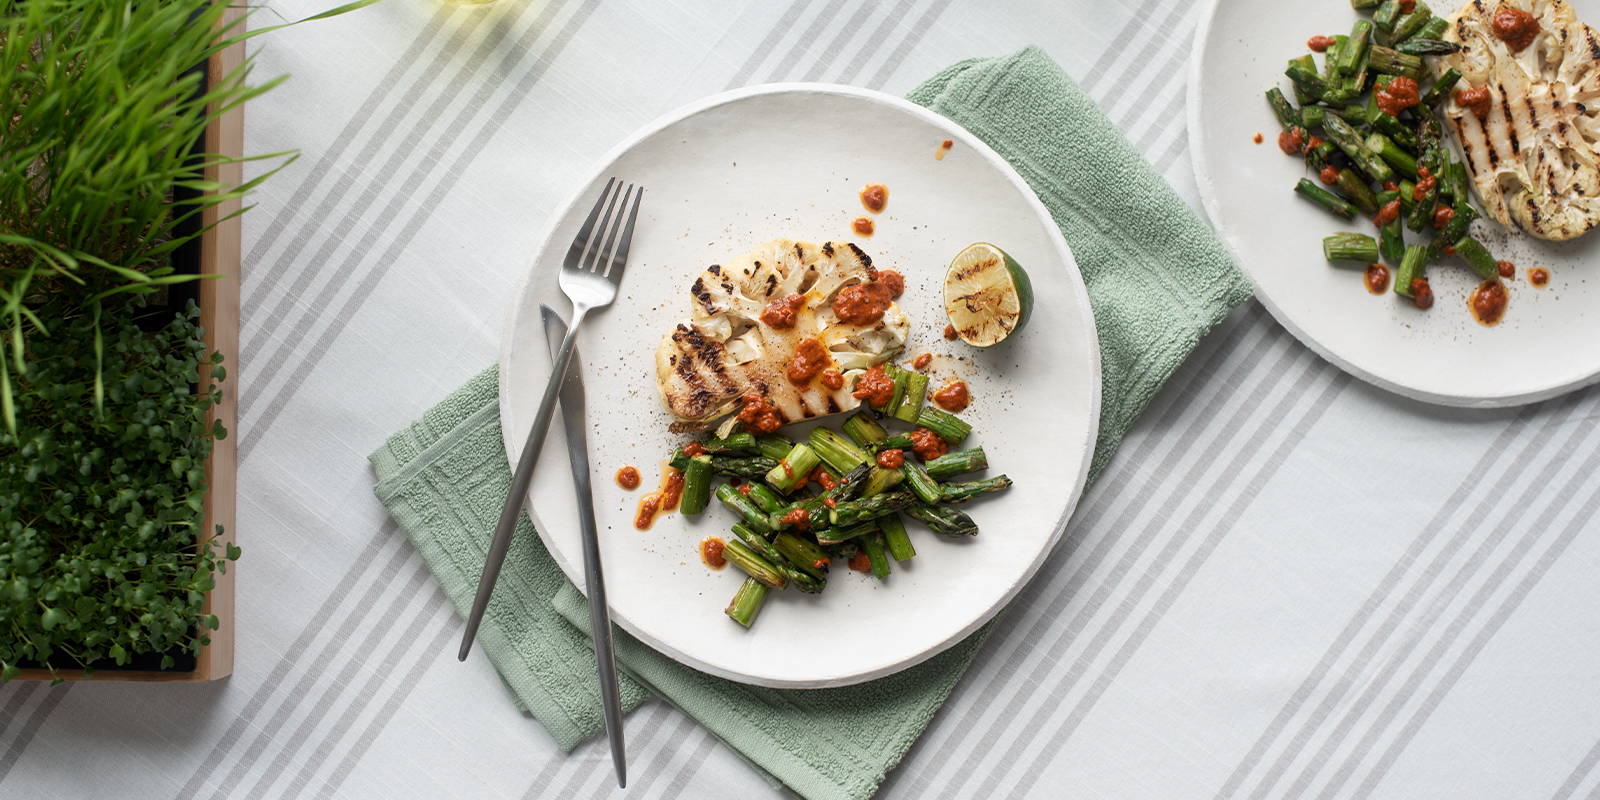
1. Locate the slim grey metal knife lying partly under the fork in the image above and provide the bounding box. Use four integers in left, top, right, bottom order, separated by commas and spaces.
539, 306, 627, 787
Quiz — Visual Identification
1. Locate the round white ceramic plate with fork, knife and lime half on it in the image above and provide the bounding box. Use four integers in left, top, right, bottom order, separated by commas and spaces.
501, 85, 1099, 688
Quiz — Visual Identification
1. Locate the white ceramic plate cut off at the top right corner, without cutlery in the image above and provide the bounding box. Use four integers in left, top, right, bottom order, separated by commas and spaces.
1189, 0, 1600, 406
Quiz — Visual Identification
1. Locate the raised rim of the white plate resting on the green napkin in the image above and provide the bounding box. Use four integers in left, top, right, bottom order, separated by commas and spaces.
496, 82, 1104, 690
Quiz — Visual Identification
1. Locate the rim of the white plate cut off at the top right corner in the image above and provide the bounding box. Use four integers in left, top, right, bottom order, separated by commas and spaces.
1184, 0, 1600, 408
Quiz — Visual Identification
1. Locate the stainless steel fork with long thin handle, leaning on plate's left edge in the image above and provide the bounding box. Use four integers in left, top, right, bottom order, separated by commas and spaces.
456, 178, 645, 661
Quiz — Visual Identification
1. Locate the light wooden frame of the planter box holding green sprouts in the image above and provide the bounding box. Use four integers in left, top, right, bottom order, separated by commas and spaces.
16, 8, 245, 683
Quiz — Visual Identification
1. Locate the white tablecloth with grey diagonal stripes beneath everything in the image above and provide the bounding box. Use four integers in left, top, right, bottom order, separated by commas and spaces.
0, 0, 1600, 800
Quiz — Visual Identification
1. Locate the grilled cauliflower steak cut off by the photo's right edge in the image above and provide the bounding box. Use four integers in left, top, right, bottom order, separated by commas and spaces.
1434, 0, 1600, 240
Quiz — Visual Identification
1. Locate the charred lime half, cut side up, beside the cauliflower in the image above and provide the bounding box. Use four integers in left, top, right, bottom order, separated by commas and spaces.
944, 242, 1034, 347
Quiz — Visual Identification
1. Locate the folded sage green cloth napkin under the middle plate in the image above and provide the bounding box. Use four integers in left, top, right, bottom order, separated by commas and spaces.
371, 48, 1250, 800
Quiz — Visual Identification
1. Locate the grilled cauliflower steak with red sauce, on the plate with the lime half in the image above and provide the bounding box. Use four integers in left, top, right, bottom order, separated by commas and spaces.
656, 238, 910, 424
